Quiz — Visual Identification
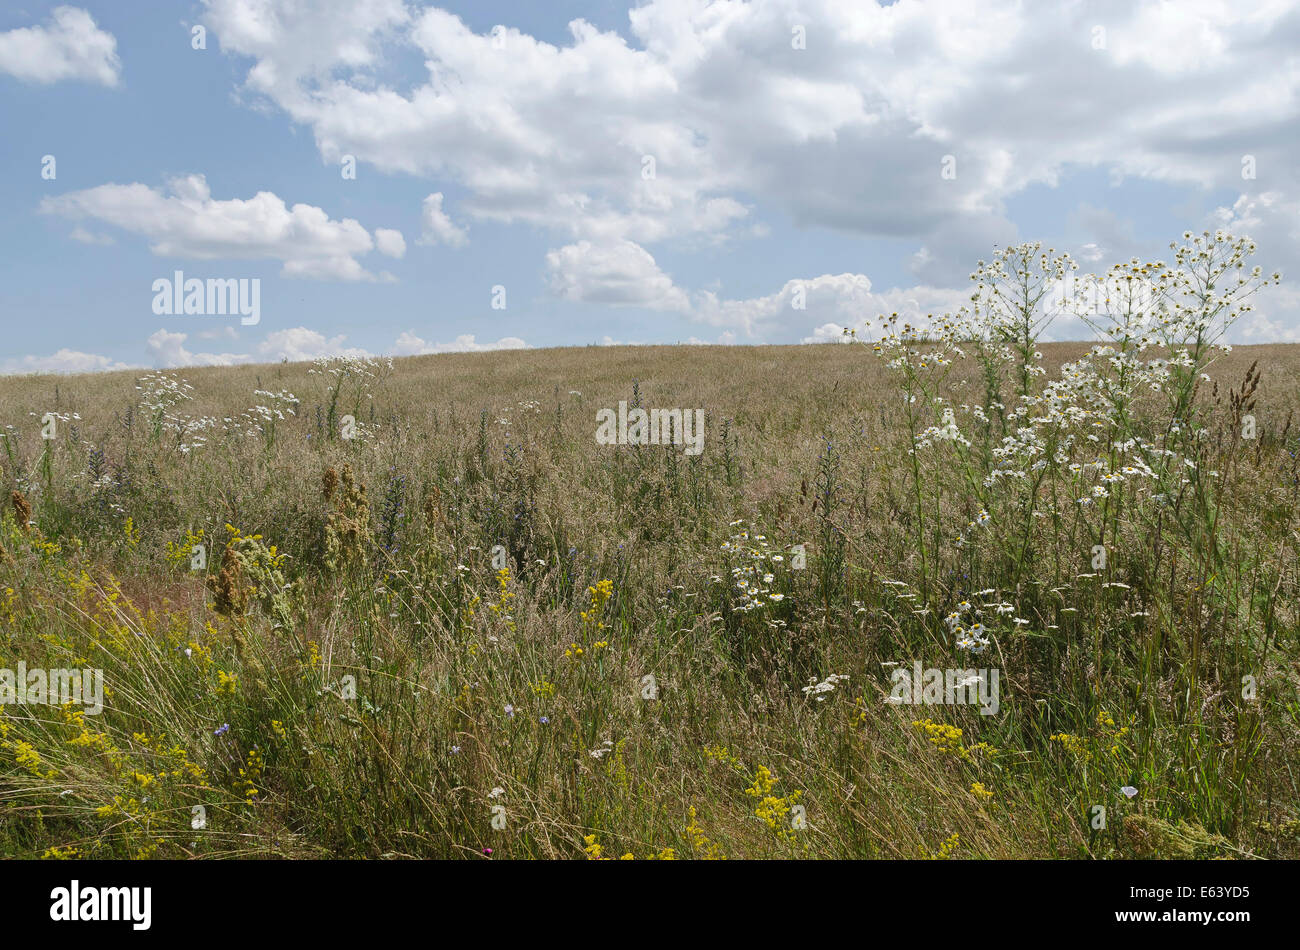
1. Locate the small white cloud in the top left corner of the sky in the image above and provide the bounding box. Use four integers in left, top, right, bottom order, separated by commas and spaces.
0, 6, 122, 86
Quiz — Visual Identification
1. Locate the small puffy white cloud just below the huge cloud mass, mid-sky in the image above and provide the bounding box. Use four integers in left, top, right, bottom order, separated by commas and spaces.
546, 240, 690, 312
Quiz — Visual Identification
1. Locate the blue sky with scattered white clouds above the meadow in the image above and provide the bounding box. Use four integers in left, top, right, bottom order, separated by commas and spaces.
0, 0, 1300, 373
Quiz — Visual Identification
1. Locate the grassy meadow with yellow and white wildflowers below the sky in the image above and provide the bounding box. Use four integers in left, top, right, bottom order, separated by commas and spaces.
0, 239, 1300, 859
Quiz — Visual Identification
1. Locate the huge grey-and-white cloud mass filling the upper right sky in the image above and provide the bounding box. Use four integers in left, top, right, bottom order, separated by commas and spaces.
205, 0, 1300, 283
